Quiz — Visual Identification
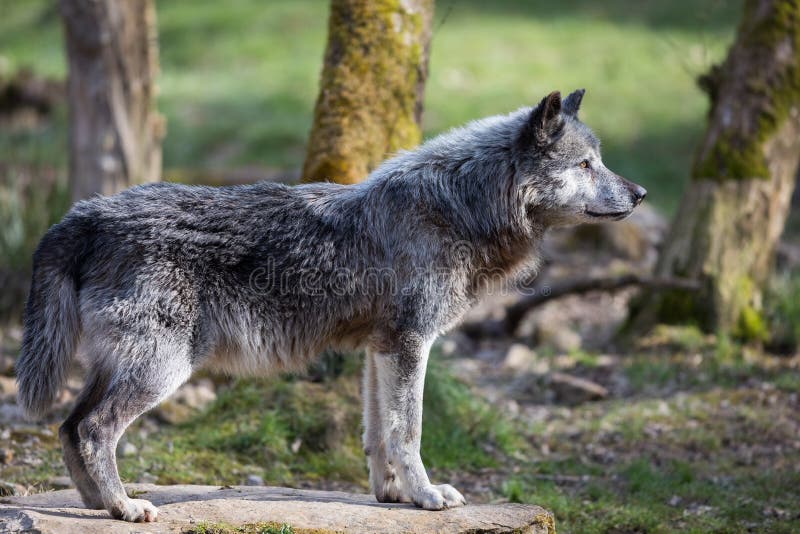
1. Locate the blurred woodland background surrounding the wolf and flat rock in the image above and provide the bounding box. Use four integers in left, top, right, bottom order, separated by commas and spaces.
0, 0, 800, 532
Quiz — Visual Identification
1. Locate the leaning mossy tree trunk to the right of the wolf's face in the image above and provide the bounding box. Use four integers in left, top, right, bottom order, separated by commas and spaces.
640, 0, 800, 338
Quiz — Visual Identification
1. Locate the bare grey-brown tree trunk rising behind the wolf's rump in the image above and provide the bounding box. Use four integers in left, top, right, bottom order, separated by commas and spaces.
60, 0, 164, 200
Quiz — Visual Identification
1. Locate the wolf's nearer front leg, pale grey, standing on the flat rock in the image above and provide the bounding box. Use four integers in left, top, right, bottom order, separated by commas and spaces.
374, 338, 466, 510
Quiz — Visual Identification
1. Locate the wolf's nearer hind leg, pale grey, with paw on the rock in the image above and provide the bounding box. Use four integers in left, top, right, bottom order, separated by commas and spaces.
78, 344, 192, 522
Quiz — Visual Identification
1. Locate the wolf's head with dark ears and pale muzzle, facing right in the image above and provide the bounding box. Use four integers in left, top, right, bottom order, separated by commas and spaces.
513, 89, 647, 226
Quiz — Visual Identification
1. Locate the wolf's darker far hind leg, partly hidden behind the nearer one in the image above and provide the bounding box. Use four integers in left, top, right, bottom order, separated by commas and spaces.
58, 370, 109, 509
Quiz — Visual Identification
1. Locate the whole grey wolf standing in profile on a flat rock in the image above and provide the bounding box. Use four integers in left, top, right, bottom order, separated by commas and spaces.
16, 90, 646, 522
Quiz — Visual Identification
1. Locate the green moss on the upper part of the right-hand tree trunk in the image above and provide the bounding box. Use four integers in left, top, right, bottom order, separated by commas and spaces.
693, 0, 800, 180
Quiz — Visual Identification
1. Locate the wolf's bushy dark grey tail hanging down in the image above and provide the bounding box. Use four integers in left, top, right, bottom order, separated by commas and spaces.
16, 221, 87, 419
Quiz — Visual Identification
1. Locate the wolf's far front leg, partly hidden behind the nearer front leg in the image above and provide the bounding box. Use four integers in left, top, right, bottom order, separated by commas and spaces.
362, 350, 408, 502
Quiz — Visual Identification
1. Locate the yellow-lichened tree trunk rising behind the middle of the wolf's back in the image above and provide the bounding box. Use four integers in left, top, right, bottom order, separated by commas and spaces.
303, 0, 433, 184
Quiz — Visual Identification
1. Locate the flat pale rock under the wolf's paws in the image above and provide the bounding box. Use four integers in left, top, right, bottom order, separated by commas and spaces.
0, 484, 555, 534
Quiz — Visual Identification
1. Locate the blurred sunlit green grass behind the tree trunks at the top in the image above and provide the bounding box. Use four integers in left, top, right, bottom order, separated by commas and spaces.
0, 0, 739, 215
